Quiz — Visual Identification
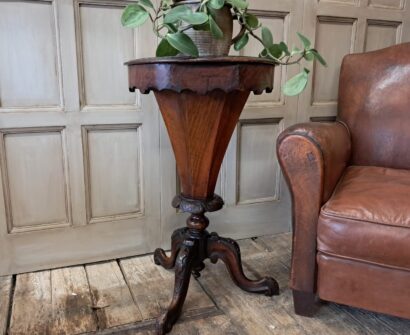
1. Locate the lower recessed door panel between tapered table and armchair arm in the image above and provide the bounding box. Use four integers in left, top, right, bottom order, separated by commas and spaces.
237, 119, 279, 204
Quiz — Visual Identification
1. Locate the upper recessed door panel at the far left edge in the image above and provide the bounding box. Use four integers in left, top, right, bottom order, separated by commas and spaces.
0, 1, 60, 108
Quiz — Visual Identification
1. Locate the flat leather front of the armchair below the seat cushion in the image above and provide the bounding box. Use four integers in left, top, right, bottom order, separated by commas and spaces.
317, 253, 410, 318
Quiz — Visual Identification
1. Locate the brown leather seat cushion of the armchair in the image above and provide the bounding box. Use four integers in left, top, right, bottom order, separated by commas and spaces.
317, 166, 410, 270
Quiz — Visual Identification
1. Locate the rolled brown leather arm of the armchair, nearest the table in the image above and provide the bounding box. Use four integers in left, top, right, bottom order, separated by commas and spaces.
277, 122, 351, 293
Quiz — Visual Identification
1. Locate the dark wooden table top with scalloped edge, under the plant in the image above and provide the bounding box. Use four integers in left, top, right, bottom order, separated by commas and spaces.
125, 56, 276, 95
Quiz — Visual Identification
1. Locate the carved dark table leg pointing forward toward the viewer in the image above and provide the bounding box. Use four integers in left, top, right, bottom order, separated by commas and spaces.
157, 239, 198, 335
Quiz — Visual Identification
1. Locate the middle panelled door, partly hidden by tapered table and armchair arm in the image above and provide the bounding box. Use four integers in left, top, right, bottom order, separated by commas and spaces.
161, 0, 303, 245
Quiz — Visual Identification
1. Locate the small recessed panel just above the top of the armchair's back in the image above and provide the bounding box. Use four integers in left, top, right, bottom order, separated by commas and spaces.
365, 20, 401, 51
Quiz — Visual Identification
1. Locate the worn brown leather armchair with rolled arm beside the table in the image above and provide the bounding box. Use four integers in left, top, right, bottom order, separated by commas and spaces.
277, 43, 410, 318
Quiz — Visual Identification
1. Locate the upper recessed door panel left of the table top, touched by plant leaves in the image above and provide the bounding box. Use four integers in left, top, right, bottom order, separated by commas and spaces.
77, 4, 135, 106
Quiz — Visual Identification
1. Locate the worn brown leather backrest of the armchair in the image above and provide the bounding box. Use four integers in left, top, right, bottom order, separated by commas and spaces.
338, 43, 410, 169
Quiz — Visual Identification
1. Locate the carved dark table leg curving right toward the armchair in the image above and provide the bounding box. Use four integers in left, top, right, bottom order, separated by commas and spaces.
208, 233, 279, 296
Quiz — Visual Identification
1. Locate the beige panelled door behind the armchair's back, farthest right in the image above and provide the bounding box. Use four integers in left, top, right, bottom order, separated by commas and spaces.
298, 0, 410, 121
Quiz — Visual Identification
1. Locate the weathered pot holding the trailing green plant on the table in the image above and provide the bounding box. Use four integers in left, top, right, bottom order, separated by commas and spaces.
175, 0, 233, 57
